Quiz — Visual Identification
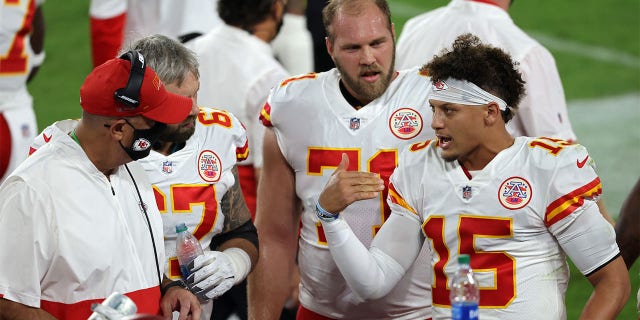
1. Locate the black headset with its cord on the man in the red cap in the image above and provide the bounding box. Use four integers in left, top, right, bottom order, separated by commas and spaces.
113, 50, 162, 288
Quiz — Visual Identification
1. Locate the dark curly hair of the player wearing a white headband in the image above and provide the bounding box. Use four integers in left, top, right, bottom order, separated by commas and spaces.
422, 33, 525, 122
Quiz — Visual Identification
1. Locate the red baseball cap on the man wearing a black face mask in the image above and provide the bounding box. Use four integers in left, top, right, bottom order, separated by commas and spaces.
80, 58, 192, 124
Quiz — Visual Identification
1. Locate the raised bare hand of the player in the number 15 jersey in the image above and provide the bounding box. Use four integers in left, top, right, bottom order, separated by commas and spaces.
318, 153, 384, 213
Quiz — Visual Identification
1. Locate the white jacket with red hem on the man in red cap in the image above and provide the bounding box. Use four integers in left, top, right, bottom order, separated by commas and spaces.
0, 124, 164, 320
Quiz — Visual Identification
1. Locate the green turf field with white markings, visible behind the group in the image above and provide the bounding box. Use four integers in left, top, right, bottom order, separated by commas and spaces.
29, 0, 640, 320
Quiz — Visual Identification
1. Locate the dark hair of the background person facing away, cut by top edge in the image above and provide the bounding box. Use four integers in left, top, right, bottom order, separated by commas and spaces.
218, 0, 278, 32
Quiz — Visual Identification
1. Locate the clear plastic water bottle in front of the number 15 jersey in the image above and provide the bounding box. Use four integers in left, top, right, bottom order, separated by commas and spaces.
449, 254, 480, 320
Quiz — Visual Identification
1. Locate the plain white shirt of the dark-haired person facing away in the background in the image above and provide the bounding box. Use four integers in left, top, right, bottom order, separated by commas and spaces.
187, 24, 288, 167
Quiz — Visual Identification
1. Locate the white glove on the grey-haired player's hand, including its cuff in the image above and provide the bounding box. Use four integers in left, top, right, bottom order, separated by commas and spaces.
187, 248, 251, 302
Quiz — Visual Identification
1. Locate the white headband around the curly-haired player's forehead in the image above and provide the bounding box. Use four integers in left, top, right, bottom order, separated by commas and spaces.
428, 78, 507, 111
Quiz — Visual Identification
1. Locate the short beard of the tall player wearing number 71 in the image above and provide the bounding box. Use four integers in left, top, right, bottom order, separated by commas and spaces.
334, 52, 396, 102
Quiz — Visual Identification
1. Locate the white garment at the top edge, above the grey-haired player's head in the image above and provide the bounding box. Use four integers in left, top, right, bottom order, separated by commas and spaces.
89, 0, 222, 44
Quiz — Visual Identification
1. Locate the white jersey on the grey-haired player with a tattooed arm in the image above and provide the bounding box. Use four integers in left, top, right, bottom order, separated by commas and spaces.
137, 108, 249, 279
